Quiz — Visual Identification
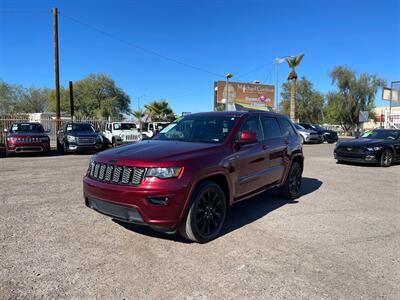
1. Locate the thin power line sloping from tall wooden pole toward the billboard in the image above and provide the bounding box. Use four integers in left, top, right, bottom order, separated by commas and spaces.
59, 12, 224, 77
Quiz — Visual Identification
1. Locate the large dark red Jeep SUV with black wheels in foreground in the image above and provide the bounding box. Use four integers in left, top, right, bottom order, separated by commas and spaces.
83, 112, 303, 243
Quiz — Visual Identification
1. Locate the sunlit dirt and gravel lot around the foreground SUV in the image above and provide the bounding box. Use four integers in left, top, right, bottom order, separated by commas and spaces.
0, 144, 400, 299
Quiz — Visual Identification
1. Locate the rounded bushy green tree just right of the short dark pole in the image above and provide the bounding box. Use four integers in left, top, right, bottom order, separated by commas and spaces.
74, 74, 130, 118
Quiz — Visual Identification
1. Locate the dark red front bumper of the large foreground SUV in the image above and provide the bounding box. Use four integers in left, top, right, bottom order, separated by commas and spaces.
83, 176, 188, 231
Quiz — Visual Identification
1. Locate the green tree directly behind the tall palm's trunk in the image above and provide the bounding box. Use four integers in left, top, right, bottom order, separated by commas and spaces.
281, 76, 324, 123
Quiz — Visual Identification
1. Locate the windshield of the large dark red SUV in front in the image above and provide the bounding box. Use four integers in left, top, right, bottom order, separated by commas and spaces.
154, 116, 239, 143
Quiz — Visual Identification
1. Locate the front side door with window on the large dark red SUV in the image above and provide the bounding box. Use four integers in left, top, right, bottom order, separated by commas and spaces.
232, 115, 267, 197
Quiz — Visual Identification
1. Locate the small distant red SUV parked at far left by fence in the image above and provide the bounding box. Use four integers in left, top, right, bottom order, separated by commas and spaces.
4, 122, 50, 156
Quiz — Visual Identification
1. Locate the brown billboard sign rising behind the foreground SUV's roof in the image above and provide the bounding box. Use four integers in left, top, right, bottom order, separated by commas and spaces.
214, 81, 275, 111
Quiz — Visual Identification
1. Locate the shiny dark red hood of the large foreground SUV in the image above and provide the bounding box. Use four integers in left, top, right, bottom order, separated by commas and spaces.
96, 140, 221, 163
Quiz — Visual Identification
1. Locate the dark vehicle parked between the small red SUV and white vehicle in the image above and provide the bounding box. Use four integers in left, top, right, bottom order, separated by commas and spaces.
57, 122, 103, 154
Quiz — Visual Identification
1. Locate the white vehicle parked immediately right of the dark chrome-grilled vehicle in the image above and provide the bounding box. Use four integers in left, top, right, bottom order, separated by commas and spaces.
103, 122, 142, 147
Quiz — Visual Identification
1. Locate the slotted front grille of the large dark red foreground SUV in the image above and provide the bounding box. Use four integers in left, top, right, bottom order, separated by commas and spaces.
89, 162, 145, 185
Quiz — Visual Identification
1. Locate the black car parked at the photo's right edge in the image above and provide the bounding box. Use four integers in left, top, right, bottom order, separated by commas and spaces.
334, 129, 400, 167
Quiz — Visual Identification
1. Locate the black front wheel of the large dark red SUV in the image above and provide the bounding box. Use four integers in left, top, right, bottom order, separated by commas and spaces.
179, 181, 227, 243
